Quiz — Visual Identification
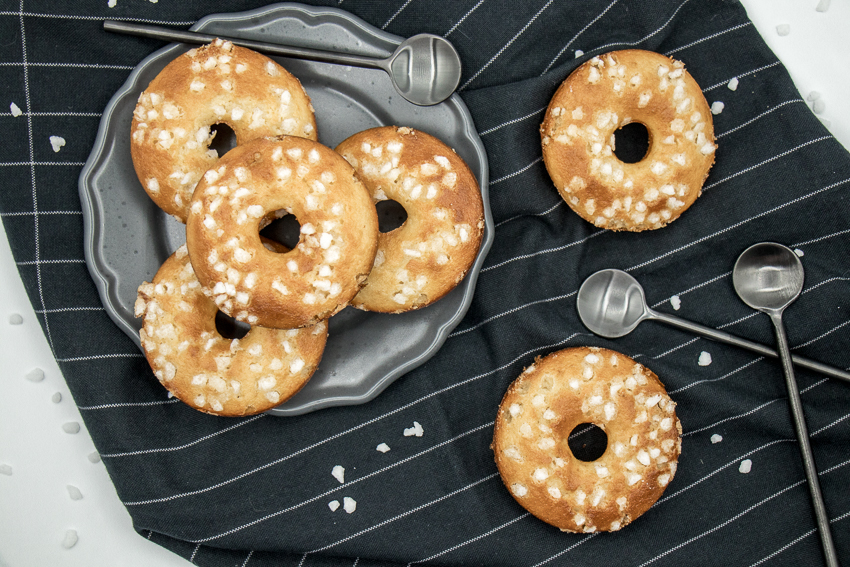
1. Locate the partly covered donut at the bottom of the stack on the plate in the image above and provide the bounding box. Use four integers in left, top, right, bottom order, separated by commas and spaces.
135, 245, 328, 416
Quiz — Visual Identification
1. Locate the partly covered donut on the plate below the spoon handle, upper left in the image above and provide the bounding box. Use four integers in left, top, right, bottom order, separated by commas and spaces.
130, 39, 316, 223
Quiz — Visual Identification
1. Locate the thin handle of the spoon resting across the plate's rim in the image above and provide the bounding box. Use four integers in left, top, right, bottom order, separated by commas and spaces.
103, 20, 384, 69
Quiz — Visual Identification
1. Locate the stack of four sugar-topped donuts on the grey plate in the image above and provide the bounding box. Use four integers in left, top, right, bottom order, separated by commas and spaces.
131, 40, 484, 416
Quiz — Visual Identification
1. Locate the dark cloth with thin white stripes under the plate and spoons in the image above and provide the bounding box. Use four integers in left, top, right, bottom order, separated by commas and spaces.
0, 0, 850, 567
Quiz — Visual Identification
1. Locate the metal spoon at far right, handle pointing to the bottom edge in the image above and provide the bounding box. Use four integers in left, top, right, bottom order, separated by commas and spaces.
732, 242, 838, 567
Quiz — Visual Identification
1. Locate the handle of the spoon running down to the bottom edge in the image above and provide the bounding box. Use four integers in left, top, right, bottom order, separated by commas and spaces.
769, 311, 839, 567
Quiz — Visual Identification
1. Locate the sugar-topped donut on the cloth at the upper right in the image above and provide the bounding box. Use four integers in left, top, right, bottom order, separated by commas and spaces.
540, 49, 717, 232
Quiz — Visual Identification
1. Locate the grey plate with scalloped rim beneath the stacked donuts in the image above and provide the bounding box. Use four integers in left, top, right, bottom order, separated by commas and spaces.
80, 4, 494, 415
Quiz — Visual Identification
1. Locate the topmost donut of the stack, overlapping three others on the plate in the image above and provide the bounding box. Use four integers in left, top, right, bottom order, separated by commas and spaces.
186, 136, 378, 329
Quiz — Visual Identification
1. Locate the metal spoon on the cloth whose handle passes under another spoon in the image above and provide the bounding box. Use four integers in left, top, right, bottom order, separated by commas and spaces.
576, 269, 850, 382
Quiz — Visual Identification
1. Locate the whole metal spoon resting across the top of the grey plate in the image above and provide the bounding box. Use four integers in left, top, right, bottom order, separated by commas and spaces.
103, 20, 461, 106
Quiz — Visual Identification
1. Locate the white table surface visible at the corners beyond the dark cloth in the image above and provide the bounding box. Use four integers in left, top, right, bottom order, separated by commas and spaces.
0, 0, 850, 567
